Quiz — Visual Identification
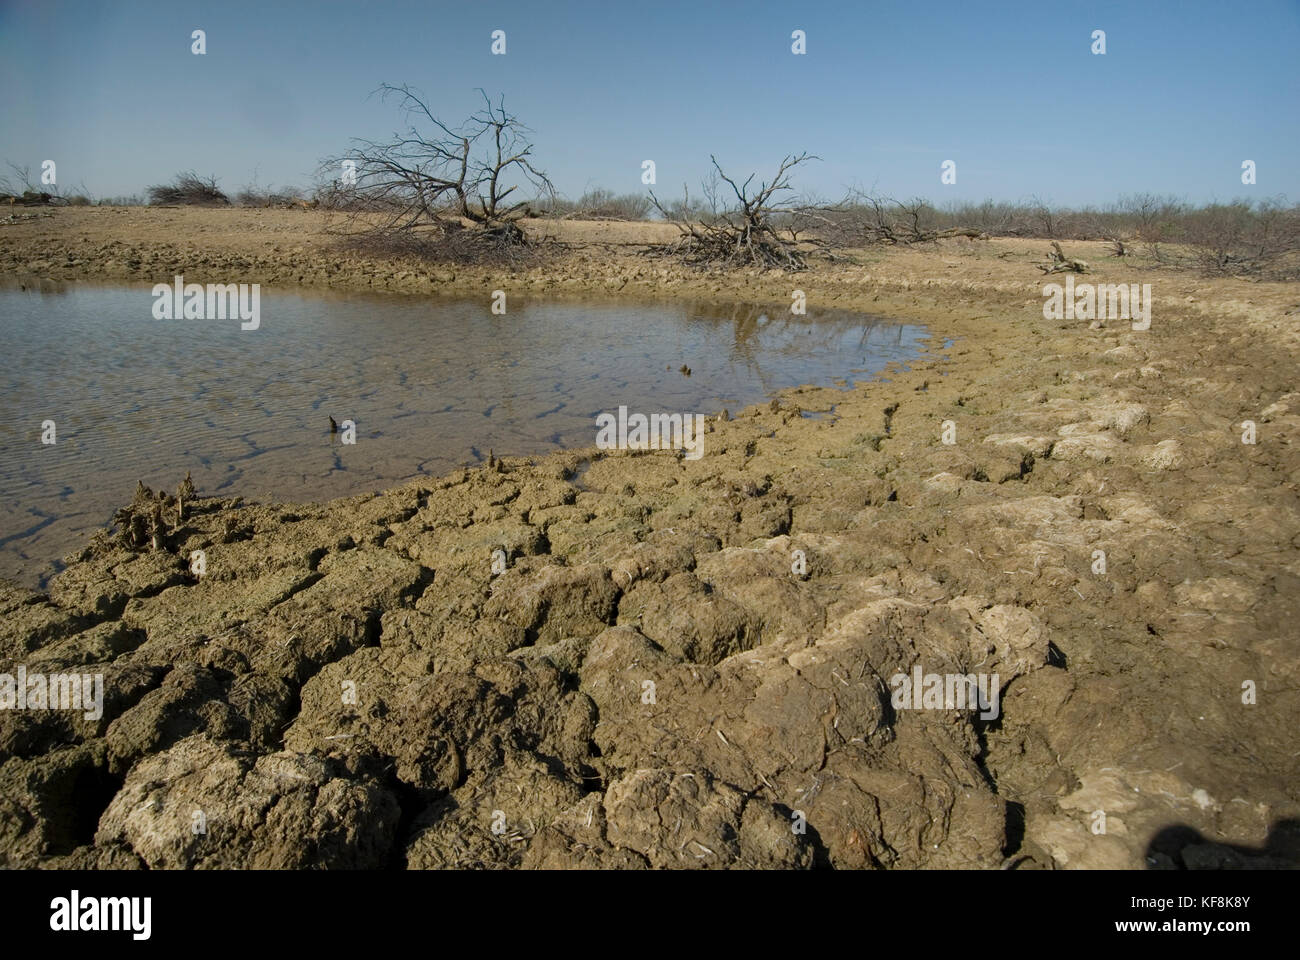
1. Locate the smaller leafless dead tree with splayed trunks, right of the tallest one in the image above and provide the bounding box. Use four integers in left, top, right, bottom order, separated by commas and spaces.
650, 153, 823, 271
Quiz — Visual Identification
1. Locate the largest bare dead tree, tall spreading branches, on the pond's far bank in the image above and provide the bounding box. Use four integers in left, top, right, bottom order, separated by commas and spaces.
321, 85, 555, 259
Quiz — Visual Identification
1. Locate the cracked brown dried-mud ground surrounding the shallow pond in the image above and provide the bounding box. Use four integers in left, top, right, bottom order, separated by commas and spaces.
0, 208, 1300, 869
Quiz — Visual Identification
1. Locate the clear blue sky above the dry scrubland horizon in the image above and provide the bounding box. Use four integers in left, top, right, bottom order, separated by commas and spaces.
0, 0, 1300, 206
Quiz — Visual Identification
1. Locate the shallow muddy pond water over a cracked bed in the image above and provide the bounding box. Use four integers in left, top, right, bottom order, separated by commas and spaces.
0, 280, 926, 585
